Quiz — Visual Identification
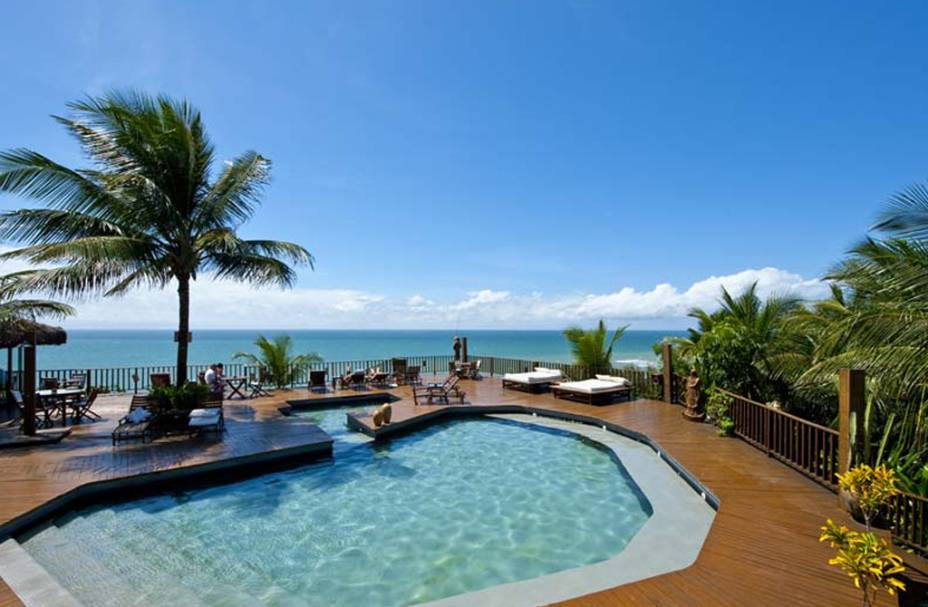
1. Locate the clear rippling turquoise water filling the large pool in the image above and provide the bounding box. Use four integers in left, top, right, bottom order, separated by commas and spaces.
20, 416, 651, 607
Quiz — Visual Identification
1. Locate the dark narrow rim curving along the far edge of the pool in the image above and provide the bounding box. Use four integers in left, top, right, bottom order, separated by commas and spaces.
346, 404, 720, 510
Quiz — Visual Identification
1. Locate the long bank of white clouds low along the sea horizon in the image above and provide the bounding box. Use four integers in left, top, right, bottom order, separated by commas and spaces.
0, 247, 828, 329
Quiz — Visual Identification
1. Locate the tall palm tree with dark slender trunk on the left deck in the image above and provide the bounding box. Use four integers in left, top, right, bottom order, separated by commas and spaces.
0, 92, 313, 384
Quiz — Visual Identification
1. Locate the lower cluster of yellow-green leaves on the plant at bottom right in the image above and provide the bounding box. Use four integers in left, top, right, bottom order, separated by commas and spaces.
819, 519, 905, 607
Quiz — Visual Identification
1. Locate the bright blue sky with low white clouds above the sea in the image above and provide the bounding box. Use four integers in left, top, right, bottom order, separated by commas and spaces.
0, 1, 928, 328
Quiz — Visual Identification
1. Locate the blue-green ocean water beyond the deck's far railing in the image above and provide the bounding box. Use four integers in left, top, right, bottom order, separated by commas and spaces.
38, 329, 683, 369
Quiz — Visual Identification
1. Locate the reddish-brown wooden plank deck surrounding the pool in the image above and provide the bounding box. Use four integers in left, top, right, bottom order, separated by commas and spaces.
0, 378, 912, 607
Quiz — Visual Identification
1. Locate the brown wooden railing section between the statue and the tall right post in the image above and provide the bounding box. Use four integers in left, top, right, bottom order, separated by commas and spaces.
721, 390, 838, 490
